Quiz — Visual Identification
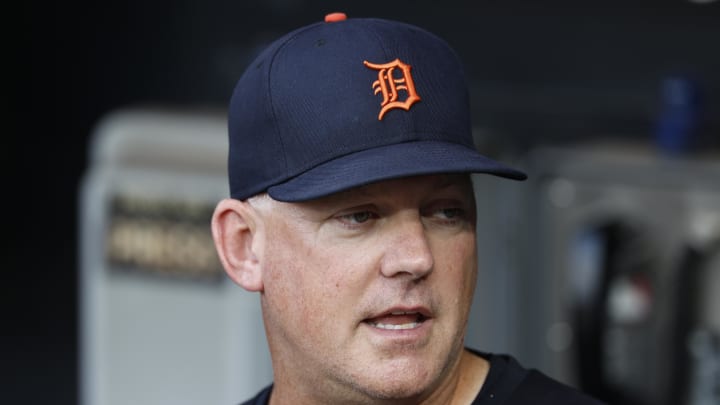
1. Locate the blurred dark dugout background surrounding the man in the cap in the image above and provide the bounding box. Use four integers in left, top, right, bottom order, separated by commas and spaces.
9, 0, 720, 405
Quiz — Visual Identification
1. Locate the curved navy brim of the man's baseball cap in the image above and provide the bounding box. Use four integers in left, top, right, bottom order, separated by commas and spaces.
268, 141, 527, 202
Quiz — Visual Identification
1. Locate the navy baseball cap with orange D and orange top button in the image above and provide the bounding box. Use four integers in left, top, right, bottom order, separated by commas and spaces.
228, 13, 526, 201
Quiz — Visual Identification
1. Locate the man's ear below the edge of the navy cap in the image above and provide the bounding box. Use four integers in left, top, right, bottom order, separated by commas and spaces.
212, 199, 263, 291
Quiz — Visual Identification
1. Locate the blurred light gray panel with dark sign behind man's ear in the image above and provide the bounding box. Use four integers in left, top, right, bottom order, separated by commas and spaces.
80, 110, 272, 405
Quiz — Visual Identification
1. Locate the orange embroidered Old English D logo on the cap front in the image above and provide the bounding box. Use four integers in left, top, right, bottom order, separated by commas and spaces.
363, 59, 420, 120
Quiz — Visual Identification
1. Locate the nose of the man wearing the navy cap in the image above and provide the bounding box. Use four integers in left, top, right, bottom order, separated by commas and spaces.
380, 215, 434, 279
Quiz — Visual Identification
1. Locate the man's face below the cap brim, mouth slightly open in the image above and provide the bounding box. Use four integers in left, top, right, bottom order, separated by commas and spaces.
253, 175, 477, 399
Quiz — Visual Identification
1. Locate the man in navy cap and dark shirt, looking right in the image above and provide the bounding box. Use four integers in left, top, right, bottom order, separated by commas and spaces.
212, 13, 596, 404
